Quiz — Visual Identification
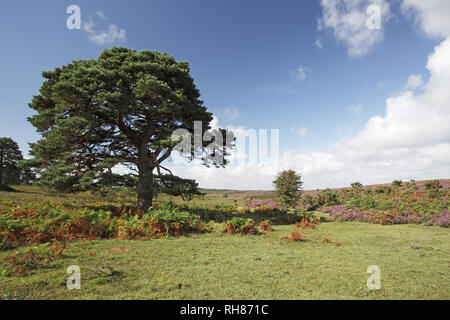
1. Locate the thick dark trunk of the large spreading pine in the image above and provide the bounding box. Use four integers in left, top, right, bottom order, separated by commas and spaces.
137, 156, 154, 214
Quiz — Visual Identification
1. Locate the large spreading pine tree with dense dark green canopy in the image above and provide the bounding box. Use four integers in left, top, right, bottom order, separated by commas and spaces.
29, 47, 229, 211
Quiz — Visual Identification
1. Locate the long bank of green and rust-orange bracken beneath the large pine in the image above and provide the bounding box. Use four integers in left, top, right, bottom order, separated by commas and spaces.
0, 200, 211, 250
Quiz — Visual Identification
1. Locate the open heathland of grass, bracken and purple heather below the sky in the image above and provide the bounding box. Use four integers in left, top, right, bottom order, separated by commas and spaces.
0, 180, 450, 299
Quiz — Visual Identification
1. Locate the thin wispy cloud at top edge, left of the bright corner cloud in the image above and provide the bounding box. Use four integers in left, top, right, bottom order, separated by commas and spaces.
318, 0, 390, 57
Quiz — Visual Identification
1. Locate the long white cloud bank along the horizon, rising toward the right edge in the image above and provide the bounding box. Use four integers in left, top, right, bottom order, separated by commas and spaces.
163, 0, 450, 190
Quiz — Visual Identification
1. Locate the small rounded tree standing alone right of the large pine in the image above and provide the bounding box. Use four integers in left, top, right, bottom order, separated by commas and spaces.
273, 170, 303, 209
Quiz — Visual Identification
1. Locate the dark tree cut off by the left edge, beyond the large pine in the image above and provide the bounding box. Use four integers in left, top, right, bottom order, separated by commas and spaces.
0, 138, 23, 185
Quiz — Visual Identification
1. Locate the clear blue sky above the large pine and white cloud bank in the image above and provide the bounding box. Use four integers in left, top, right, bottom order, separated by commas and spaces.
0, 0, 448, 188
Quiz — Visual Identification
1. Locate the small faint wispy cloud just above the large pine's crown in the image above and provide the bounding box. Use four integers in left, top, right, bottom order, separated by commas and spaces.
83, 11, 127, 45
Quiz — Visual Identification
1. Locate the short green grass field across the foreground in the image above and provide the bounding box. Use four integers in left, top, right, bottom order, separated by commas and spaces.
0, 189, 450, 299
